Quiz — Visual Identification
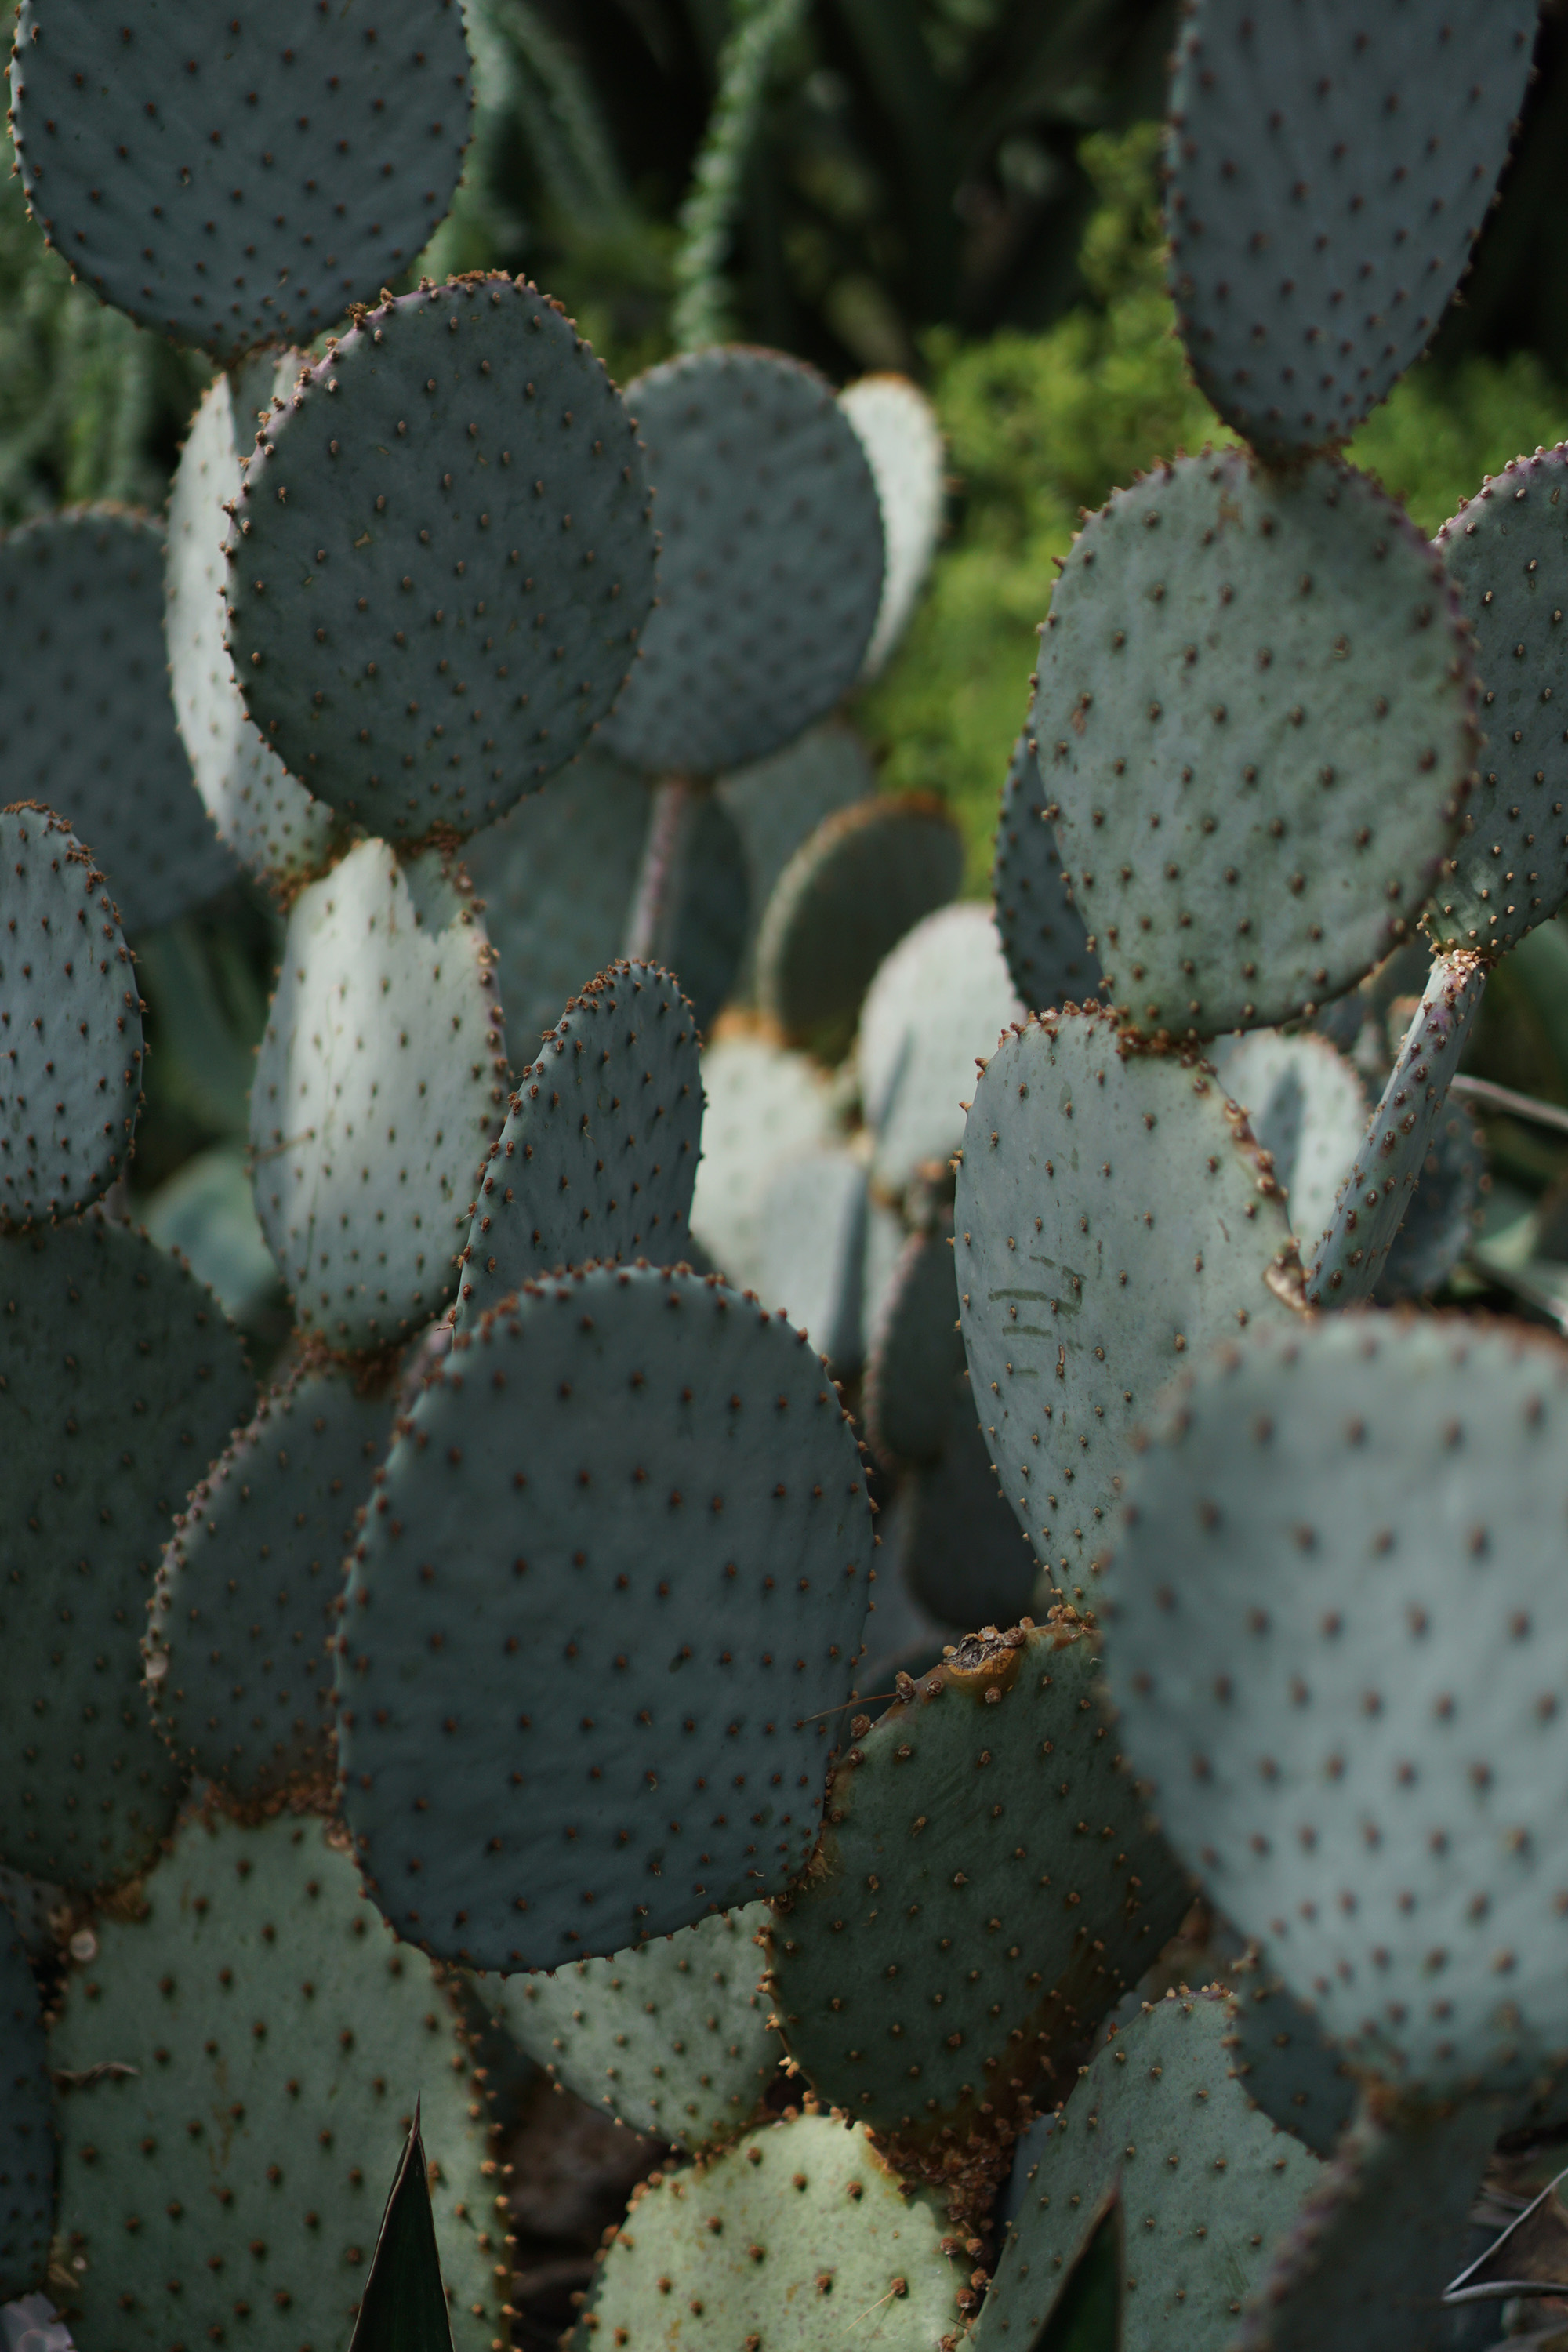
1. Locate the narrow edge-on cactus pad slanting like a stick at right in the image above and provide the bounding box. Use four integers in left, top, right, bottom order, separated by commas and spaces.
1302, 948, 1486, 1308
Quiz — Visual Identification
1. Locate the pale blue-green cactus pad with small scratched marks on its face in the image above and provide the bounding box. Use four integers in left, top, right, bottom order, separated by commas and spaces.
954, 1014, 1300, 1595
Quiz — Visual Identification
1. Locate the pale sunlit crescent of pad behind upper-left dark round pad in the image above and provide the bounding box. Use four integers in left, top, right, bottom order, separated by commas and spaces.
165, 350, 334, 882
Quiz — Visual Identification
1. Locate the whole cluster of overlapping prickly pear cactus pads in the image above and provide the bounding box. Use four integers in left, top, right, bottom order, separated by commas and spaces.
0, 0, 1568, 2352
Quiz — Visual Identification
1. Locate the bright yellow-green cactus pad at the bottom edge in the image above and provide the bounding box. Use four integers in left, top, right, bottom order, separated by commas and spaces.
569, 2112, 975, 2352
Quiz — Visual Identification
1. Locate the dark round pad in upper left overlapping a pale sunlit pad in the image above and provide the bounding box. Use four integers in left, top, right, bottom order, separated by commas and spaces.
228, 278, 654, 842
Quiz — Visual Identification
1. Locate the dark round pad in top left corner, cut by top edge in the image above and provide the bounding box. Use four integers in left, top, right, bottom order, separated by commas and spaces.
12, 0, 468, 360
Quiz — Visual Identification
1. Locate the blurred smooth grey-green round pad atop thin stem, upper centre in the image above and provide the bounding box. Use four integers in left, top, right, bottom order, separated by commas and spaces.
604, 348, 881, 776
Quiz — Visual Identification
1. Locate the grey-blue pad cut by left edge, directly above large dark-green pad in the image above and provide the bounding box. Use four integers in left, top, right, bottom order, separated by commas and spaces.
0, 807, 141, 1228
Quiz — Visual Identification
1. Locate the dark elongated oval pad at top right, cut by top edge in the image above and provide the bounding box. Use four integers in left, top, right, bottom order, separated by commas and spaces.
1166, 0, 1535, 456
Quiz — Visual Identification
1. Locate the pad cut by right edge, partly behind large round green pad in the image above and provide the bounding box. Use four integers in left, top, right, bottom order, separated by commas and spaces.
1427, 442, 1568, 955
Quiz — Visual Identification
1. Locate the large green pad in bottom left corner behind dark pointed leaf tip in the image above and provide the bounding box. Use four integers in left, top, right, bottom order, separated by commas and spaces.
49, 1813, 510, 2352
